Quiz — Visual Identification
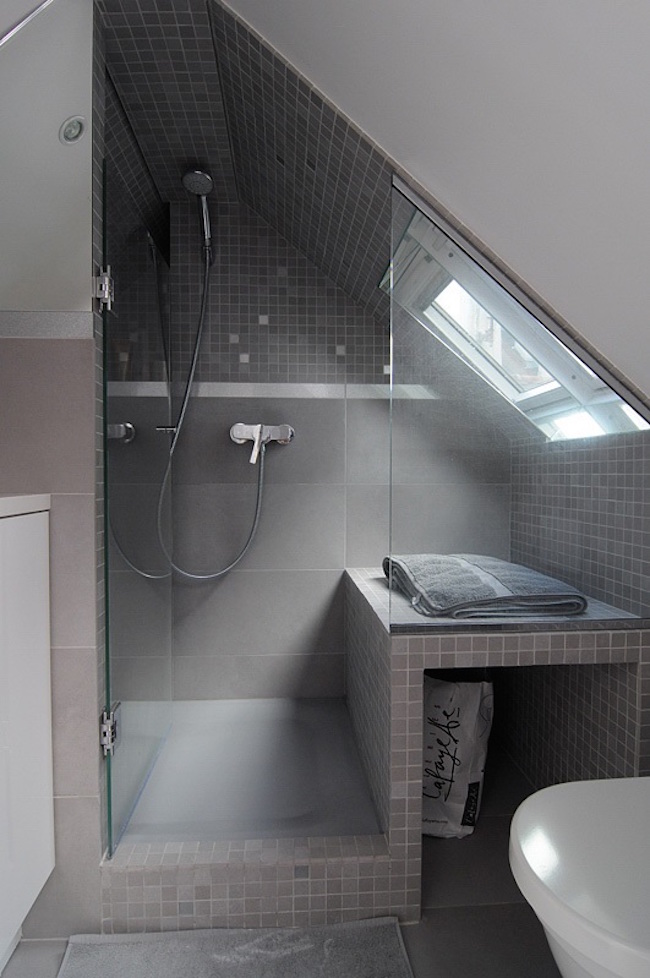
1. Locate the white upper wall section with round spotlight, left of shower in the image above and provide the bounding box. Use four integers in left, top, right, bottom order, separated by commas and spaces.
0, 0, 93, 311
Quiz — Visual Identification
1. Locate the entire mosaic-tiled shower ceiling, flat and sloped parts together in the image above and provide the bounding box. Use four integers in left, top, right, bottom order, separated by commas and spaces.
97, 0, 391, 324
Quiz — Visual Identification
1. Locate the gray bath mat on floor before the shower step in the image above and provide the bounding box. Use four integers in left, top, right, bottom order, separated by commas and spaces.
58, 917, 413, 978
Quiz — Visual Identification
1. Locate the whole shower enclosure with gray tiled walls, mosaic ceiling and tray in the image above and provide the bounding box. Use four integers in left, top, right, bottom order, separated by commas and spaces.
96, 0, 389, 851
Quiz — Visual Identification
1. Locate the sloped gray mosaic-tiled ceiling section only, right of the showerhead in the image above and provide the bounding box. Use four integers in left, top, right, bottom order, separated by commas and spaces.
210, 2, 392, 323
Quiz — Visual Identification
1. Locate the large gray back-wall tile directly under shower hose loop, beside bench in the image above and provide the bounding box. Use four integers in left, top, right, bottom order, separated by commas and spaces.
174, 570, 343, 661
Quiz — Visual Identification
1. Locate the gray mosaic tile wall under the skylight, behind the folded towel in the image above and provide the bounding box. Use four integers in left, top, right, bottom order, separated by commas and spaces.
512, 431, 650, 616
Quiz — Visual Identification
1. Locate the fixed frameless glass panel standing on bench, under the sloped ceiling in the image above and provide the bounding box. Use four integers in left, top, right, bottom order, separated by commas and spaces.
382, 182, 650, 629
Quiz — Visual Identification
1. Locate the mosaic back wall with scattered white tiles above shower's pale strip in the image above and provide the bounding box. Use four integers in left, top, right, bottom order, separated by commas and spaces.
172, 196, 389, 383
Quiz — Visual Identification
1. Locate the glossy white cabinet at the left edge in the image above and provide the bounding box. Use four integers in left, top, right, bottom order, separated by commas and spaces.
0, 496, 54, 970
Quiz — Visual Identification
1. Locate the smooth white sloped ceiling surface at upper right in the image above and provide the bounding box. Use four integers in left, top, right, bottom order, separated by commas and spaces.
223, 0, 650, 393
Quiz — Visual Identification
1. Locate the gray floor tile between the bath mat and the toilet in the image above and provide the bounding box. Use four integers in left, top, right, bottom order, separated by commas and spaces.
402, 904, 560, 978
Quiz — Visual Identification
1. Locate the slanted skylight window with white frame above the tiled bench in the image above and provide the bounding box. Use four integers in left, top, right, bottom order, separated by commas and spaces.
382, 197, 650, 440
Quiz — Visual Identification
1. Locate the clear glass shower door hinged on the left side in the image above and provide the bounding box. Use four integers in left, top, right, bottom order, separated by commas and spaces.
104, 156, 172, 855
